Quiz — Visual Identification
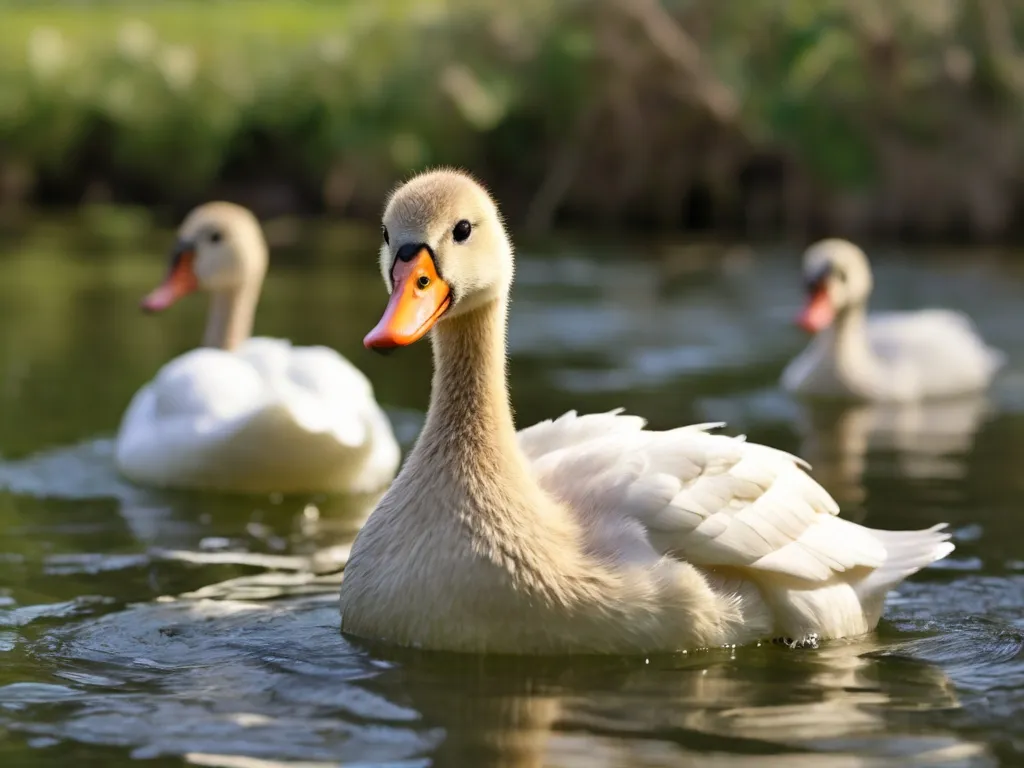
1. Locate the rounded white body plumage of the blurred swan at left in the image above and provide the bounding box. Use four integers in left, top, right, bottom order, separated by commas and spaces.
117, 338, 399, 493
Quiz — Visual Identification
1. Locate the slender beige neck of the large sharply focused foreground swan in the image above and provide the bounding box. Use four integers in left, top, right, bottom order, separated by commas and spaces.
417, 297, 516, 463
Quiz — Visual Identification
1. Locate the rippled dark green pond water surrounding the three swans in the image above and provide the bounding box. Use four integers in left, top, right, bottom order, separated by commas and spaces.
0, 216, 1024, 768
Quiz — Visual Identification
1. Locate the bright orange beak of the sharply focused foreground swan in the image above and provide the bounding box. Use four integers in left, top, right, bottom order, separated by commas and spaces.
362, 246, 452, 350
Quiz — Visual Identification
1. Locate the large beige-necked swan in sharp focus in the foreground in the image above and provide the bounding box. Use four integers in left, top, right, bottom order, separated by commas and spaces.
341, 171, 952, 653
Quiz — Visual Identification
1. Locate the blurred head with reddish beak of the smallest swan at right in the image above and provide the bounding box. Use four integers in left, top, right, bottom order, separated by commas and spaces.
797, 239, 871, 333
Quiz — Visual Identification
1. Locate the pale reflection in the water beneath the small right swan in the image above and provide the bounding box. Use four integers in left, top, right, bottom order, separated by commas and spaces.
797, 395, 989, 514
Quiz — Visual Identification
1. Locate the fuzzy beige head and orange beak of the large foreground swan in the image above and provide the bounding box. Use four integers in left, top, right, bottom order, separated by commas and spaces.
362, 170, 513, 350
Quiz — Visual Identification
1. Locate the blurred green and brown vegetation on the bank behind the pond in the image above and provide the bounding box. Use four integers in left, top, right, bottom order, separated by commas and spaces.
0, 0, 1024, 239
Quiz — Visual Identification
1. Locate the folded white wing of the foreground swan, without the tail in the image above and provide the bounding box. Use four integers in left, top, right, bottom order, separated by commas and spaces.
519, 411, 935, 583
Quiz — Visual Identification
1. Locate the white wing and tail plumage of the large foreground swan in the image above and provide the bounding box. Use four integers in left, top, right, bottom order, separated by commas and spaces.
519, 411, 953, 639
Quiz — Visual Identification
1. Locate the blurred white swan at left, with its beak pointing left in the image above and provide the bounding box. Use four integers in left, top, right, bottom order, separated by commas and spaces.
116, 203, 399, 493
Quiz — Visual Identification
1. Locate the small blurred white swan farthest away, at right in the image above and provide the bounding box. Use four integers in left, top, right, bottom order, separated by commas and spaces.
782, 240, 1006, 402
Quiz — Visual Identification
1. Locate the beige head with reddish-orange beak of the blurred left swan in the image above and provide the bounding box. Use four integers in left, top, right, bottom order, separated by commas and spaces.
142, 203, 267, 312
